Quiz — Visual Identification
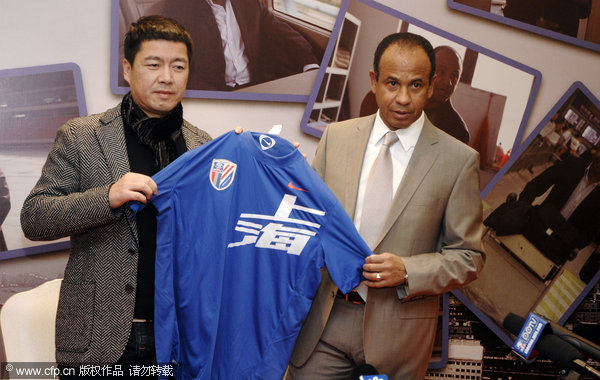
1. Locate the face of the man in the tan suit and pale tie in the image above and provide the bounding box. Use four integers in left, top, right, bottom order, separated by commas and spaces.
369, 44, 433, 130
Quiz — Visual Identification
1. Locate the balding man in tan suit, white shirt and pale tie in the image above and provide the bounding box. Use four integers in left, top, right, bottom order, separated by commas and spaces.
288, 33, 484, 379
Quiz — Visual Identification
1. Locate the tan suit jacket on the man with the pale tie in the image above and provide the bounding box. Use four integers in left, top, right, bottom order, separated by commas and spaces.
291, 115, 484, 379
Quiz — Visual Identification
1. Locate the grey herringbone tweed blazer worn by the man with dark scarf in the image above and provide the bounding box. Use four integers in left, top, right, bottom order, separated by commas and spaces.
21, 105, 211, 365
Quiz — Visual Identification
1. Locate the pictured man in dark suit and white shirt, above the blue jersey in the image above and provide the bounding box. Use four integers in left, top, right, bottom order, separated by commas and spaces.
147, 0, 319, 91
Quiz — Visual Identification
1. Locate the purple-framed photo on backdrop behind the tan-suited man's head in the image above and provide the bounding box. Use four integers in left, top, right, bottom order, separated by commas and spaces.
301, 0, 541, 189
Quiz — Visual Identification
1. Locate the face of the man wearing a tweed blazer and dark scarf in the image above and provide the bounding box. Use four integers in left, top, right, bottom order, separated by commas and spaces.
123, 40, 189, 117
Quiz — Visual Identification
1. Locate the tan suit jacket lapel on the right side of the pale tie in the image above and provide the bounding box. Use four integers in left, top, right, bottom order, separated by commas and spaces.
375, 119, 439, 247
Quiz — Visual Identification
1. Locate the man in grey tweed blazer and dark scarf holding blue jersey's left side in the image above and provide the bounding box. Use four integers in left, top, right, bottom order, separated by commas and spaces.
21, 16, 211, 371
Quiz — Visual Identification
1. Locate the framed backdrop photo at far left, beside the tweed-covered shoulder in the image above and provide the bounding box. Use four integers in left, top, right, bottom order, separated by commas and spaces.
0, 63, 87, 260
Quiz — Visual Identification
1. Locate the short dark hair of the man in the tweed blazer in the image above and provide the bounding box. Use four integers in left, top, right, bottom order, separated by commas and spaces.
123, 15, 194, 65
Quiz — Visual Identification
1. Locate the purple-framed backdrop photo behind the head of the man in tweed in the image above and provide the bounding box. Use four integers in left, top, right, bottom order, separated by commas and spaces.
110, 0, 341, 102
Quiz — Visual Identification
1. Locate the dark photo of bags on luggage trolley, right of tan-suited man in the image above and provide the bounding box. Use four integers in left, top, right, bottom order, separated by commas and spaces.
463, 88, 600, 330
